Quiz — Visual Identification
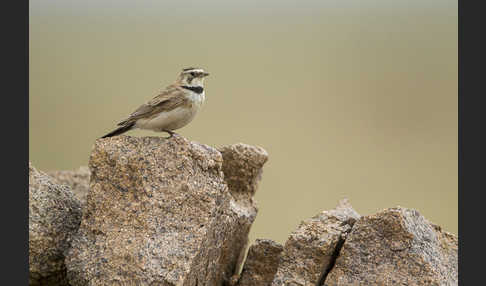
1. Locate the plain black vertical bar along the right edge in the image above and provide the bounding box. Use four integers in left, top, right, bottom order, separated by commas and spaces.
458, 1, 486, 285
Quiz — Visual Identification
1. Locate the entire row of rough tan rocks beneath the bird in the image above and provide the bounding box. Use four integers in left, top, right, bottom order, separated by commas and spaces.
29, 136, 458, 286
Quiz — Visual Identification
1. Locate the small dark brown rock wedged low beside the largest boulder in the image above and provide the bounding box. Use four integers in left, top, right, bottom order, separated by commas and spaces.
237, 239, 283, 286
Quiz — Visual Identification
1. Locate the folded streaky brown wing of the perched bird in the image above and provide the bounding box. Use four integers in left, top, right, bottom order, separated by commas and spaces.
118, 85, 188, 125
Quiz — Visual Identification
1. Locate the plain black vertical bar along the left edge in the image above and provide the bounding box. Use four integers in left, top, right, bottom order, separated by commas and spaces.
0, 0, 29, 285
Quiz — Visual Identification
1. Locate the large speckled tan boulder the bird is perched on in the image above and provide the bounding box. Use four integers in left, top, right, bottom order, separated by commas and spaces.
66, 136, 266, 286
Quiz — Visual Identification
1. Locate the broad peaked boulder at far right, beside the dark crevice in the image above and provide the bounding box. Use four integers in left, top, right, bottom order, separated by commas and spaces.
325, 207, 458, 286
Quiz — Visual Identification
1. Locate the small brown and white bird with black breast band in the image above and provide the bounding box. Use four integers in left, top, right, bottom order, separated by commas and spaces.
101, 68, 209, 138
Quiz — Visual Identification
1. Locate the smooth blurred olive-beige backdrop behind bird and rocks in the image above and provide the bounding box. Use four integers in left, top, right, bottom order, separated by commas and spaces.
29, 0, 458, 243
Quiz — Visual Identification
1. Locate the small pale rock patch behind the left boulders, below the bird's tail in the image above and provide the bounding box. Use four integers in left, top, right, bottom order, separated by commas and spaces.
46, 166, 90, 207
